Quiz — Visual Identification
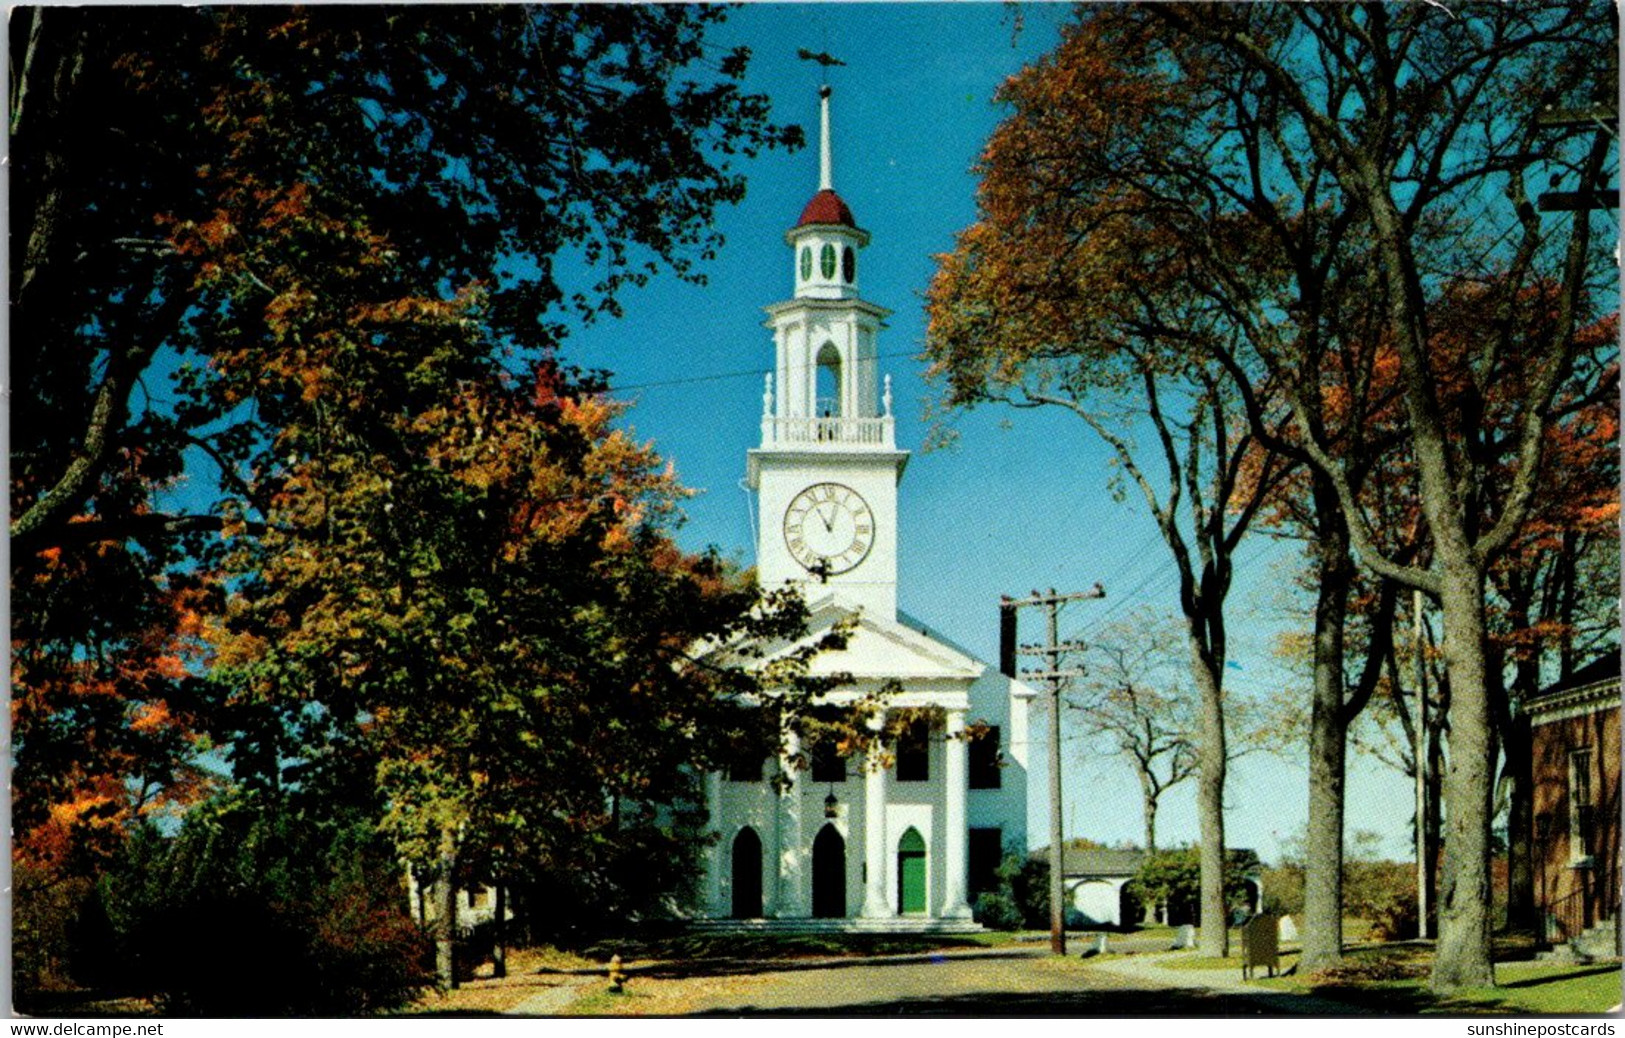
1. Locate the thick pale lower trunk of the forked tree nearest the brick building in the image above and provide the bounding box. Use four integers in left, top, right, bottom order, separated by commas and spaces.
1432, 565, 1495, 993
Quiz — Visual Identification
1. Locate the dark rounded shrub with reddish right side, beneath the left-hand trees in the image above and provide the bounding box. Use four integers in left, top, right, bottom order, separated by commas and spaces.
75, 798, 432, 1017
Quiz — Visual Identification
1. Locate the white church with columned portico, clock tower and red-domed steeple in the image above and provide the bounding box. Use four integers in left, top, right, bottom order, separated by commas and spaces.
696, 86, 1035, 929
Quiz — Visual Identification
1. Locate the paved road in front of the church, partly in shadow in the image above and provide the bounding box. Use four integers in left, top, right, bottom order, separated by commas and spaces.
697, 949, 1345, 1017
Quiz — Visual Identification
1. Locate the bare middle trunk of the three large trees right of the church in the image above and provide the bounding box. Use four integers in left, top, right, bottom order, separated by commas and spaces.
1298, 516, 1352, 973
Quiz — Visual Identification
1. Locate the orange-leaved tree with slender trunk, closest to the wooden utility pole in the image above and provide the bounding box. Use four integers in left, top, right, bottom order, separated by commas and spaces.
926, 14, 1292, 955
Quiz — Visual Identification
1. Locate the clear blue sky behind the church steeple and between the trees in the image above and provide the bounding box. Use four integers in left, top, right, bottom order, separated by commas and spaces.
566, 3, 1411, 859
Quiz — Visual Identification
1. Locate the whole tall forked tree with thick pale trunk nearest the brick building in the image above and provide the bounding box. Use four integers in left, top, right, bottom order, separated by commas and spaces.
1159, 3, 1610, 991
